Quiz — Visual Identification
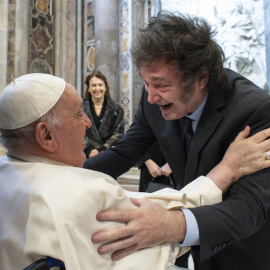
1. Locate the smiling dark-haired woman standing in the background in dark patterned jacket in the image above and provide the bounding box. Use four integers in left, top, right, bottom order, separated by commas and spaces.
83, 71, 125, 157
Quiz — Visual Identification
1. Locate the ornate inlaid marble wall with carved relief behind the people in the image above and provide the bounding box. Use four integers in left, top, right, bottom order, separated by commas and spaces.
3, 0, 270, 128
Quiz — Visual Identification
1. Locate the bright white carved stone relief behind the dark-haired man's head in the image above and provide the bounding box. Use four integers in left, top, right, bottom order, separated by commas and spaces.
161, 0, 267, 89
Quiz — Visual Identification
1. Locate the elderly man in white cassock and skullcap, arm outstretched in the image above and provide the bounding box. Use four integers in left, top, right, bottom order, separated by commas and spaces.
0, 73, 270, 270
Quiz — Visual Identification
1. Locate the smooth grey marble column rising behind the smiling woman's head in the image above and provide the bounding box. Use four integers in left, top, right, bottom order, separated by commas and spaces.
95, 0, 120, 102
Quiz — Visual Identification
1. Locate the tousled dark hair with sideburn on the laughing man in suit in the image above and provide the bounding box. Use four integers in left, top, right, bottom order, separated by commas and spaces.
131, 11, 228, 91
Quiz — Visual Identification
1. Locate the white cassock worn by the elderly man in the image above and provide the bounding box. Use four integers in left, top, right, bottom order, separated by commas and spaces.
0, 155, 222, 270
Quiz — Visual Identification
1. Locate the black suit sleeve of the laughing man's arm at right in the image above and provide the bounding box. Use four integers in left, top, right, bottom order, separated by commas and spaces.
191, 100, 270, 261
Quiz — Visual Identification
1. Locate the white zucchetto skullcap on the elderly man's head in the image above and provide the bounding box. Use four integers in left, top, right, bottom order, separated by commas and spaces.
0, 73, 66, 129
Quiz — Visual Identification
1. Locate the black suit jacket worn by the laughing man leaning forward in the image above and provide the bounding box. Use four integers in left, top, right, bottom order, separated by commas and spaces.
85, 70, 270, 270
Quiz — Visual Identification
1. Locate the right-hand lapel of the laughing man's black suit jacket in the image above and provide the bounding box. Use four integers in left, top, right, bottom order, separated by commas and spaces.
185, 93, 225, 184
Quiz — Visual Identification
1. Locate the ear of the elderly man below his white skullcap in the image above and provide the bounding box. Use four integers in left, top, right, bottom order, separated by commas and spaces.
35, 122, 57, 153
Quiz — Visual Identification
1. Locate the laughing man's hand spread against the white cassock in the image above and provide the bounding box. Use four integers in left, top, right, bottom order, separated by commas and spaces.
92, 199, 186, 260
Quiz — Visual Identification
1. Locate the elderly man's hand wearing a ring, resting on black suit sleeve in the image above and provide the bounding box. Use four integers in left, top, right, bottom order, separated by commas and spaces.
207, 126, 270, 191
